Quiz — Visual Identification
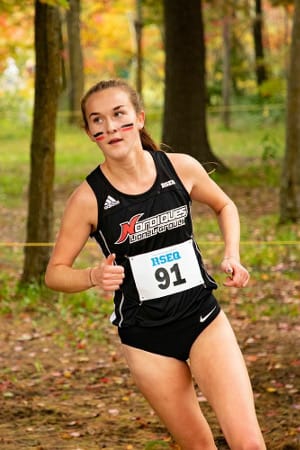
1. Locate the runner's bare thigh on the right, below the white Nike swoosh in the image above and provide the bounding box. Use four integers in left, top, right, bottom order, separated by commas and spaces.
190, 312, 264, 448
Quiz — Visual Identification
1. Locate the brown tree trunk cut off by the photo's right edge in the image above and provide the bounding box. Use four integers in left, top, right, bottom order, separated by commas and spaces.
280, 0, 300, 223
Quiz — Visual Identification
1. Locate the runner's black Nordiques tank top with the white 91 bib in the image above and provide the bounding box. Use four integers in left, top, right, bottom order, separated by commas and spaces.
86, 150, 217, 327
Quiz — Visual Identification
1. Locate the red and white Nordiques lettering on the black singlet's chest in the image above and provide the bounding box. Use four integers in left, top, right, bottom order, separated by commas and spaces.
115, 205, 188, 244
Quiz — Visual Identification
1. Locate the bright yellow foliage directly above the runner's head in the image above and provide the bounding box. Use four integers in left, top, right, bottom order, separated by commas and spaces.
81, 0, 164, 81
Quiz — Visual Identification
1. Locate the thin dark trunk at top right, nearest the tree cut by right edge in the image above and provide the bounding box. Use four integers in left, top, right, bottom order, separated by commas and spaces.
253, 0, 268, 86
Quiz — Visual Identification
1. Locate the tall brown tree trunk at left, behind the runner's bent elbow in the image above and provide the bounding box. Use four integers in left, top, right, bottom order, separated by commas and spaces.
21, 1, 61, 283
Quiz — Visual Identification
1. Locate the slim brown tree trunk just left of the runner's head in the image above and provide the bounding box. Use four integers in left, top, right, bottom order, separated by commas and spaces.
67, 0, 84, 125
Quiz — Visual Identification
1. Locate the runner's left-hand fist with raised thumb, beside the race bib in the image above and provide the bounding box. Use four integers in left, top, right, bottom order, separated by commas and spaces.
90, 253, 125, 291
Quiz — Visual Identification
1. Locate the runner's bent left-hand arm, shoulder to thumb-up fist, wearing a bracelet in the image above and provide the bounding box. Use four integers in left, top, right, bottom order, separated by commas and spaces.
45, 182, 124, 293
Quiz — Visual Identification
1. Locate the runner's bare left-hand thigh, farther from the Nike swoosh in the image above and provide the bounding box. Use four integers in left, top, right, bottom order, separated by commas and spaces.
122, 344, 215, 450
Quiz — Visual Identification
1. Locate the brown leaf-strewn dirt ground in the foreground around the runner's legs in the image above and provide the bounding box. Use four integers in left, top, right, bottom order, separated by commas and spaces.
0, 298, 300, 450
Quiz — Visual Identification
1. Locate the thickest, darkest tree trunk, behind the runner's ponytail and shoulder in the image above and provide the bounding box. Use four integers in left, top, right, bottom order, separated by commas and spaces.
163, 0, 224, 169
